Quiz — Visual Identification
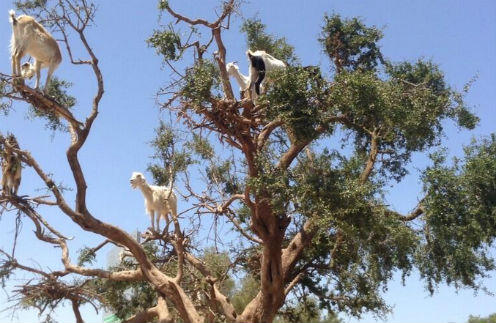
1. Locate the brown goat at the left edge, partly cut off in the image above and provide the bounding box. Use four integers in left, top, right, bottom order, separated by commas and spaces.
0, 134, 22, 195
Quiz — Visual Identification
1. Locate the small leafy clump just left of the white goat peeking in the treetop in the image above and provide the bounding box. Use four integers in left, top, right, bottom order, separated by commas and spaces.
180, 60, 220, 109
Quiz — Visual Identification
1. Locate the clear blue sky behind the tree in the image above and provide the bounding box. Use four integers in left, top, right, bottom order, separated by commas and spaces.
0, 0, 496, 323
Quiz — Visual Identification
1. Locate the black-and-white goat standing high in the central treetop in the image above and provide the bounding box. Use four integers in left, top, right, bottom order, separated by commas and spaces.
246, 50, 286, 99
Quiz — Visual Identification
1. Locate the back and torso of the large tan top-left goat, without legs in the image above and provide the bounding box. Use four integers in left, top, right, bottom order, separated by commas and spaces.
11, 15, 62, 66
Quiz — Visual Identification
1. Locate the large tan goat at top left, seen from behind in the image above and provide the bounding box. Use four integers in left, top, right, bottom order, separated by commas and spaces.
9, 10, 62, 90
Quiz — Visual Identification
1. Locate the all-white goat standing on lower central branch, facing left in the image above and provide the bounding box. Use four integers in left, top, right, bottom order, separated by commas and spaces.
129, 172, 177, 232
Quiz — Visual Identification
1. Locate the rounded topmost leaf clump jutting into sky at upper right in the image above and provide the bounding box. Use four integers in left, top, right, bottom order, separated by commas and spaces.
319, 14, 383, 72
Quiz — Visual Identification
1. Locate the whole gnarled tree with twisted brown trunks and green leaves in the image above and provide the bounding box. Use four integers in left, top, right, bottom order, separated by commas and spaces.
0, 0, 496, 322
